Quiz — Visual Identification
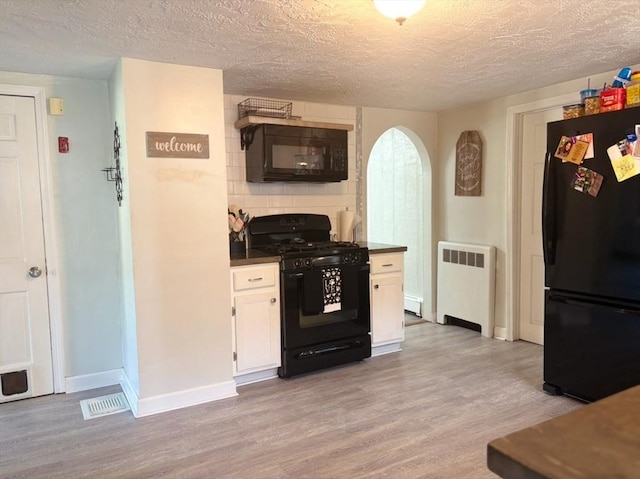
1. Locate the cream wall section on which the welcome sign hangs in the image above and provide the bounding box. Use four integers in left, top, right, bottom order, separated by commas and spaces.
122, 58, 235, 406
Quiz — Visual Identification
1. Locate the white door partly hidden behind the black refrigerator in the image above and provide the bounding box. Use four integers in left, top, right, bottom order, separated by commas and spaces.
519, 108, 562, 344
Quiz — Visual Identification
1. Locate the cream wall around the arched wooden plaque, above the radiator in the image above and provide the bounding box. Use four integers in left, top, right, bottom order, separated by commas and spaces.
434, 66, 639, 334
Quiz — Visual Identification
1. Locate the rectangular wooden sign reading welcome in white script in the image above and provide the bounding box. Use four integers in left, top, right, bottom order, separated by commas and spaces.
147, 131, 209, 158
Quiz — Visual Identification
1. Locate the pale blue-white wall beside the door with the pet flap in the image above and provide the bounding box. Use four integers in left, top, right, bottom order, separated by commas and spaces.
0, 72, 122, 377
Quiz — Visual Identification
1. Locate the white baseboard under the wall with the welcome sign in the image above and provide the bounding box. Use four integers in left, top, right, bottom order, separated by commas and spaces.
134, 380, 238, 417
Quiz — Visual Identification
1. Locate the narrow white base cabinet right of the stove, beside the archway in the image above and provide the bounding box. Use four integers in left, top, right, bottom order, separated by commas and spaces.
370, 253, 404, 356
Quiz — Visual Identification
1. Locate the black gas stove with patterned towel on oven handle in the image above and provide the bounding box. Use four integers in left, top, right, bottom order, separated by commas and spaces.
247, 214, 371, 378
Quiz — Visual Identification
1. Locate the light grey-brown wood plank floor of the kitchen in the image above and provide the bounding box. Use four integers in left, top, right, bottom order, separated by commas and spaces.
0, 323, 582, 479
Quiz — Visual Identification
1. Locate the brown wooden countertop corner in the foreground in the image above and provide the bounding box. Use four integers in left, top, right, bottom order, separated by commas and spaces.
487, 386, 640, 479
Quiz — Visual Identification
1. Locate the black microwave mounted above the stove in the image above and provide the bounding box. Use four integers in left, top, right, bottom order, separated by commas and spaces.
246, 124, 349, 183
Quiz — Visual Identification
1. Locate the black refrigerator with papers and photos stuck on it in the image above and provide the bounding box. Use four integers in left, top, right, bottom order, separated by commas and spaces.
542, 108, 640, 402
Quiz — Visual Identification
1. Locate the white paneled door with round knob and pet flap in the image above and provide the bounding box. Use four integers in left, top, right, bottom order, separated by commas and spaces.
0, 95, 53, 402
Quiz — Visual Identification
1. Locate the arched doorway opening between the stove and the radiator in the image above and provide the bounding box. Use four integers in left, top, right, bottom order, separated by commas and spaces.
367, 127, 431, 317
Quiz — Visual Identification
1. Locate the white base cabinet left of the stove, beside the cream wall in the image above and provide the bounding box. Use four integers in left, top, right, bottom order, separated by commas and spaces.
231, 263, 280, 384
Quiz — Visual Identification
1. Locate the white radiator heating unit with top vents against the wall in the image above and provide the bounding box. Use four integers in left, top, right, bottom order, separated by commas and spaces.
436, 241, 496, 338
